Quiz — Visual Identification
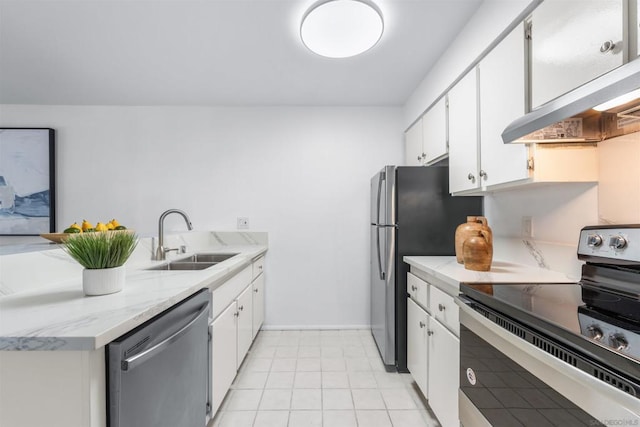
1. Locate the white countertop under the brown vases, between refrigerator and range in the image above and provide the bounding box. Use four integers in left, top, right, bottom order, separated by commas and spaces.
403, 256, 577, 290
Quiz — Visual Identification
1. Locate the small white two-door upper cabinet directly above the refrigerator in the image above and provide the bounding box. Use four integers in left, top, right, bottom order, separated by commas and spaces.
405, 97, 448, 166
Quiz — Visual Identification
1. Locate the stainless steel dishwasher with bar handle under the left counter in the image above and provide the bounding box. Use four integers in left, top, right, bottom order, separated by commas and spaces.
106, 289, 211, 427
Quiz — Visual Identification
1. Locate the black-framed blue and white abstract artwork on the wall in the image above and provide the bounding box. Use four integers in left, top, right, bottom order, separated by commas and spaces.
0, 128, 56, 236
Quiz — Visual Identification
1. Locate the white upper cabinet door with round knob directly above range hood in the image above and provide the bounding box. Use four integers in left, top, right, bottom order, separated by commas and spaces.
528, 0, 627, 108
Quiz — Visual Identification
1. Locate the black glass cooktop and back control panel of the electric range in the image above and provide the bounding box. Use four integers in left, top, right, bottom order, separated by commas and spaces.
460, 225, 640, 399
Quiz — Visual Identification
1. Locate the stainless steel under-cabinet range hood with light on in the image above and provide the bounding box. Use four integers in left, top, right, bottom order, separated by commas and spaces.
502, 59, 640, 144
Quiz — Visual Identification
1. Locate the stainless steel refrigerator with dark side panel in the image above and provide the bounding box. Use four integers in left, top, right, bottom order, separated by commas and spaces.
370, 166, 483, 372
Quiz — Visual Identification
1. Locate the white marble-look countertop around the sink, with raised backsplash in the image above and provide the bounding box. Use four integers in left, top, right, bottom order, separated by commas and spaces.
0, 232, 267, 351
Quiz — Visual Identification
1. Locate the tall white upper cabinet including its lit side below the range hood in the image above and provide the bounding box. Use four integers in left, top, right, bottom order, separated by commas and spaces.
449, 24, 598, 195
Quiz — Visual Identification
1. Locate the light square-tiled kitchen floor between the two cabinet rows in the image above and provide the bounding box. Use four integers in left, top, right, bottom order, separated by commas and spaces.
210, 330, 439, 427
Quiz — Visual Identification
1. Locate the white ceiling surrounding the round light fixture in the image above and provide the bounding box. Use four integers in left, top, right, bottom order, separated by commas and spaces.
0, 0, 482, 106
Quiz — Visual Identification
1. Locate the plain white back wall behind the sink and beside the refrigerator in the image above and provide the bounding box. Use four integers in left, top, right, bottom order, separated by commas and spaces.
0, 105, 402, 327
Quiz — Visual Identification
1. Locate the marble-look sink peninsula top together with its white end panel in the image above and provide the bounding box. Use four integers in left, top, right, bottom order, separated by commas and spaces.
0, 232, 267, 427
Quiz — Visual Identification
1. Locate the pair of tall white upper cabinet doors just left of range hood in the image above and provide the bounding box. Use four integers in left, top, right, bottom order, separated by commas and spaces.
449, 25, 531, 193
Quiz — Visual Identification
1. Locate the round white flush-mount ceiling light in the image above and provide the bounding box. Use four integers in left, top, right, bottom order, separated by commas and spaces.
300, 0, 384, 58
